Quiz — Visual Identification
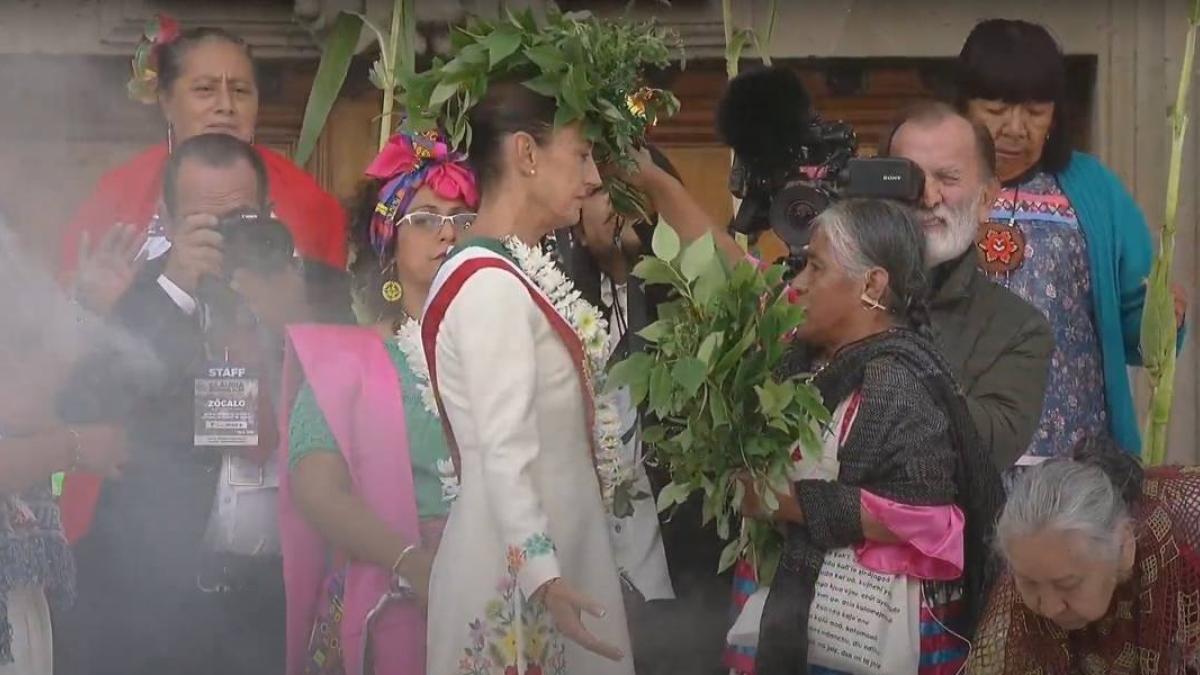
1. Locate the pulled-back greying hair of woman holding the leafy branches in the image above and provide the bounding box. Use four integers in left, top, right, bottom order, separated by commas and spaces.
816, 198, 934, 339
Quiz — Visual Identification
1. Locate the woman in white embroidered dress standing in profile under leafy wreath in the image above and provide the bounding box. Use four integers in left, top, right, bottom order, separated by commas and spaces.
422, 82, 634, 675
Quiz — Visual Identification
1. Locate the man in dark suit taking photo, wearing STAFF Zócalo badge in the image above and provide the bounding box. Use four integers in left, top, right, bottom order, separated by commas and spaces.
68, 135, 297, 675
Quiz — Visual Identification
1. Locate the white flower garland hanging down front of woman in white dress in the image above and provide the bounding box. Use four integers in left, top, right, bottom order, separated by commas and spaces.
504, 237, 634, 513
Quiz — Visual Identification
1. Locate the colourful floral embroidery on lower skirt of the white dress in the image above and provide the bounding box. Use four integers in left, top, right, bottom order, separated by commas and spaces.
458, 554, 566, 675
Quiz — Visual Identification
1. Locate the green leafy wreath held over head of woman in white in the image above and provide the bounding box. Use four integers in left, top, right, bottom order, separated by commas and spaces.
404, 4, 679, 170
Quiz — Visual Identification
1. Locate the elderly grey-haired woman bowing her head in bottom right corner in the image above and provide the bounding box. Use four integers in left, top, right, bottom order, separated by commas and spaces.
968, 437, 1200, 675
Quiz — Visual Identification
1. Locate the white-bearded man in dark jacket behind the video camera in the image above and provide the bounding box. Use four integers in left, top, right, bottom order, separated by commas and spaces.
884, 102, 1054, 471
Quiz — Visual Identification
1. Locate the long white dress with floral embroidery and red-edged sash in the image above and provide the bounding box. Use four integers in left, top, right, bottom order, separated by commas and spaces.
425, 240, 634, 675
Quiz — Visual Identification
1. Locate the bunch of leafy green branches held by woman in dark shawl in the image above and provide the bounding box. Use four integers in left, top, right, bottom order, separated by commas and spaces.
608, 222, 829, 584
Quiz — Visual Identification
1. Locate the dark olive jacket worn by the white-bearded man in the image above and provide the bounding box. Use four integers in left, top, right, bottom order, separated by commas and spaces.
930, 251, 1054, 471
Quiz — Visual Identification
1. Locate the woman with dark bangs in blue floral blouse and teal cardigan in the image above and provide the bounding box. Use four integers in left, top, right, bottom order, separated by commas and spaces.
958, 19, 1186, 466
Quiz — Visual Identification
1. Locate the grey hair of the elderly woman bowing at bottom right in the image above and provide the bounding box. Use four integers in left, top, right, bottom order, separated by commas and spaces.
996, 459, 1129, 560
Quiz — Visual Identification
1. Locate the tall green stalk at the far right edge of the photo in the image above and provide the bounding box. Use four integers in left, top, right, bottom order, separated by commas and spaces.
1141, 0, 1200, 466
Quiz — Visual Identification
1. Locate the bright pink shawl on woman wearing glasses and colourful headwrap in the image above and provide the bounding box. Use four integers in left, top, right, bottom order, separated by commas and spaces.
277, 325, 425, 675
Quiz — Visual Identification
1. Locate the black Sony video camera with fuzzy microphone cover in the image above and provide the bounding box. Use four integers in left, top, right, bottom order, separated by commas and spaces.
716, 66, 925, 273
